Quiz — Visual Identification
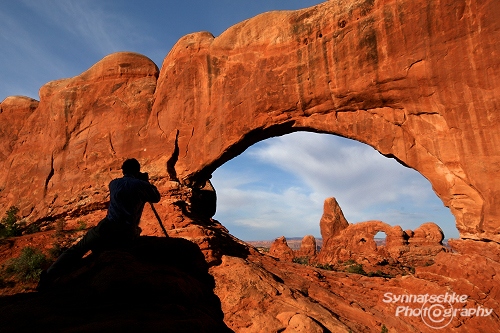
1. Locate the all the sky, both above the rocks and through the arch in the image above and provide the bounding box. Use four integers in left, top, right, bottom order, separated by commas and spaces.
0, 0, 458, 240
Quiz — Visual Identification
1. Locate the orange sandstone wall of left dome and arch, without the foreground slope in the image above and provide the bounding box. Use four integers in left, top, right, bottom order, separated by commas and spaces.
0, 0, 500, 241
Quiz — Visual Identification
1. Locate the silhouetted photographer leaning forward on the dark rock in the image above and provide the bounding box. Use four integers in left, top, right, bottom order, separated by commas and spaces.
38, 159, 160, 290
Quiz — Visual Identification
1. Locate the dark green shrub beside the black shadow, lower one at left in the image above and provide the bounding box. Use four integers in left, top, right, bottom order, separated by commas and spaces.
6, 246, 47, 282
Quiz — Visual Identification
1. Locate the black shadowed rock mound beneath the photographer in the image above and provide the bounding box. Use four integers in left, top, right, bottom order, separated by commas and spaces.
0, 237, 232, 333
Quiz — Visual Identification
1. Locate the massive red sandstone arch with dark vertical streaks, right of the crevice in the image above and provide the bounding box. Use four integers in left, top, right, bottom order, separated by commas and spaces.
153, 0, 500, 241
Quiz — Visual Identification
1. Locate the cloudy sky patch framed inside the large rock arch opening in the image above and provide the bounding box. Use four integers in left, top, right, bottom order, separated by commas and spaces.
212, 132, 458, 240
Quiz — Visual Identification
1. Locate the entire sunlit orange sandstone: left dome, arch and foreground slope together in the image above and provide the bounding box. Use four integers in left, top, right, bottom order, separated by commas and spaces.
0, 0, 500, 332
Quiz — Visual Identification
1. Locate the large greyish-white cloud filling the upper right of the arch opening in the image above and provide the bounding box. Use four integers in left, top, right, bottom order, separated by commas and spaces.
252, 132, 430, 209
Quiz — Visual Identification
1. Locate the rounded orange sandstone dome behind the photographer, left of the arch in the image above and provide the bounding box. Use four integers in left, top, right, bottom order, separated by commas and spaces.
0, 53, 158, 222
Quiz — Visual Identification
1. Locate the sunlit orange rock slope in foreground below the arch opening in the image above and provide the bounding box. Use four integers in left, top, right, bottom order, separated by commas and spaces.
210, 241, 500, 333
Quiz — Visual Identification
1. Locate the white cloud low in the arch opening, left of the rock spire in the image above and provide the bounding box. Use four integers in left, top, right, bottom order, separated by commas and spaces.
213, 170, 322, 240
